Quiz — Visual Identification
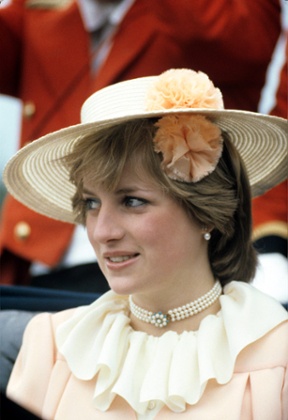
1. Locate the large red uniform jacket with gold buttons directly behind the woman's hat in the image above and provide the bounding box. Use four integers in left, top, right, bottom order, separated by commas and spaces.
0, 0, 281, 283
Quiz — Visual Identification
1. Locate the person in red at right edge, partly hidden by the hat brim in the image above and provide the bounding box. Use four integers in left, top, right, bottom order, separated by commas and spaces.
252, 39, 288, 309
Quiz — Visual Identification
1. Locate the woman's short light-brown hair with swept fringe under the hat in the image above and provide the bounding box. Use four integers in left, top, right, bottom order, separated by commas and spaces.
65, 119, 257, 285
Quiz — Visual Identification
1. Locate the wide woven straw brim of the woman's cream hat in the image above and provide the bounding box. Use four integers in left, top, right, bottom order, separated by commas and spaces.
3, 108, 287, 223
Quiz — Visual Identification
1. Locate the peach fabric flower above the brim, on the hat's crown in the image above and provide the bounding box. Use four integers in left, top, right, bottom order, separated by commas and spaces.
146, 69, 224, 111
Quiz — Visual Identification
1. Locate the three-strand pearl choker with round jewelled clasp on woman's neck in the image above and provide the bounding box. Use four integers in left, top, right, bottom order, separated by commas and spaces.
129, 280, 222, 328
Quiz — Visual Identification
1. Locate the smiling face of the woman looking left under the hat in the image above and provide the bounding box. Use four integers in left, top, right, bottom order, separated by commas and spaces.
83, 162, 209, 296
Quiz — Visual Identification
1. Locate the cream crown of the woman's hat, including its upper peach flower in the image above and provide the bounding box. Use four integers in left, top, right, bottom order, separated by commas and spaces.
81, 69, 224, 123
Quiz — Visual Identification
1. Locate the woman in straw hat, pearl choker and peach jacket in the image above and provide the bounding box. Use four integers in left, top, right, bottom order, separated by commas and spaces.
4, 69, 288, 420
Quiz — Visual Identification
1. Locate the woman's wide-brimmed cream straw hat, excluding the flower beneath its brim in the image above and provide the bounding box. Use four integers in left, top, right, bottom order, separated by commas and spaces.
3, 69, 287, 223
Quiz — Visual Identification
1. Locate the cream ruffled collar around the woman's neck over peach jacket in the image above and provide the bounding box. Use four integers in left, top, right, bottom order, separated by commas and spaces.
56, 282, 287, 415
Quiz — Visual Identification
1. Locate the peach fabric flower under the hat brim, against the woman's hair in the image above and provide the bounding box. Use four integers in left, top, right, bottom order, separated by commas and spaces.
153, 114, 222, 182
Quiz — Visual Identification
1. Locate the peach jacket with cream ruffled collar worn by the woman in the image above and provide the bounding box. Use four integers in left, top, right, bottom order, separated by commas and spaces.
7, 282, 288, 420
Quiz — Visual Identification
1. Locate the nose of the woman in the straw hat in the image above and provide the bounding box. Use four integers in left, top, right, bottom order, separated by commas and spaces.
87, 205, 124, 244
